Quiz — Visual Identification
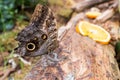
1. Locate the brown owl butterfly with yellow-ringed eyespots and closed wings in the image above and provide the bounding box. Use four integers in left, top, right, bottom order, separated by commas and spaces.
15, 4, 58, 56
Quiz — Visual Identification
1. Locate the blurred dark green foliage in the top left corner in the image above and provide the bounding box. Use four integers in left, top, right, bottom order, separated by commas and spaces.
0, 0, 47, 31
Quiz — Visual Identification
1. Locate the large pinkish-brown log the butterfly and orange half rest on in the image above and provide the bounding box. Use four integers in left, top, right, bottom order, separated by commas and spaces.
24, 14, 120, 80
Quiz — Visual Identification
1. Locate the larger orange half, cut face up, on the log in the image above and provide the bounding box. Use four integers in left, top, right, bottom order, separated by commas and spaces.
76, 21, 111, 44
